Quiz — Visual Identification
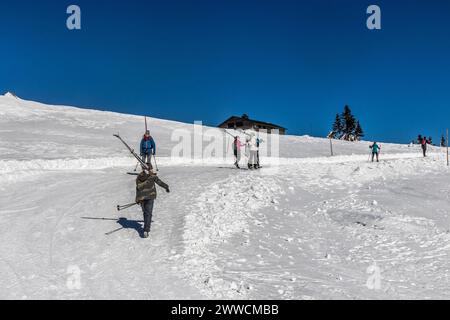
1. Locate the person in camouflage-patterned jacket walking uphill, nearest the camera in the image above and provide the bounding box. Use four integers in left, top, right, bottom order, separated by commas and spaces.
136, 163, 170, 238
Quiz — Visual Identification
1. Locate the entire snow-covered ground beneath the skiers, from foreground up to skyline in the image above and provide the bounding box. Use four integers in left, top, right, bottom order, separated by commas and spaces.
0, 96, 450, 299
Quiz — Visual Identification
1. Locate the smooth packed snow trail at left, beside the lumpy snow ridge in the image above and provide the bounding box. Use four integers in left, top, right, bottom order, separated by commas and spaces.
0, 168, 230, 299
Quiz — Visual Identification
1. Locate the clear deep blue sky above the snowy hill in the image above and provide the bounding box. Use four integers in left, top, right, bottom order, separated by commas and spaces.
0, 0, 450, 142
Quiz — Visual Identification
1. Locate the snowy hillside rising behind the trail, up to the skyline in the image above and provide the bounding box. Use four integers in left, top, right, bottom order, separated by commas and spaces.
0, 94, 422, 160
